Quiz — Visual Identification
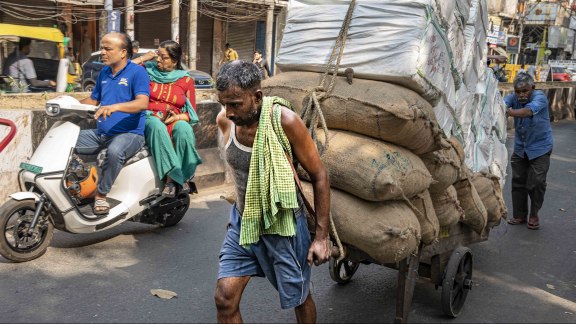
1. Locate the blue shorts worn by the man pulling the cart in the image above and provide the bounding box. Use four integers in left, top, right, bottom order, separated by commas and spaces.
218, 205, 311, 309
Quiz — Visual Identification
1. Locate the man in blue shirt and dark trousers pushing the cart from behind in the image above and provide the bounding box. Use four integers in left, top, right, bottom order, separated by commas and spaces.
504, 73, 553, 229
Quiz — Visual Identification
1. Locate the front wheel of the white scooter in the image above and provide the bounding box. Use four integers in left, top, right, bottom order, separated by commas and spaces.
0, 199, 54, 262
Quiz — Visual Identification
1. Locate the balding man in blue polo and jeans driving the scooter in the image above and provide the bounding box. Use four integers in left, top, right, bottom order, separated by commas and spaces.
76, 32, 150, 217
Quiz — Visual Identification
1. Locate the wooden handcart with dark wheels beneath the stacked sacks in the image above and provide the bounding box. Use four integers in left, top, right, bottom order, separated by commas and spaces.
329, 223, 490, 323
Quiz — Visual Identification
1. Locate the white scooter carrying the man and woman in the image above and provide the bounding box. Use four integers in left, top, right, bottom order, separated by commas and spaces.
0, 96, 197, 262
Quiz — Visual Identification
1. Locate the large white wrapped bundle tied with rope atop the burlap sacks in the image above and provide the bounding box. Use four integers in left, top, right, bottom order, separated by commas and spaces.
276, 0, 460, 103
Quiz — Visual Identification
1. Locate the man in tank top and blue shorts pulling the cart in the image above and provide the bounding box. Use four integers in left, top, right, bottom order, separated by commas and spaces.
214, 60, 330, 323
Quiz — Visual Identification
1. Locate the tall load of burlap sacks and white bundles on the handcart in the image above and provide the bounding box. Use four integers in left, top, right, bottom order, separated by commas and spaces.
263, 0, 505, 263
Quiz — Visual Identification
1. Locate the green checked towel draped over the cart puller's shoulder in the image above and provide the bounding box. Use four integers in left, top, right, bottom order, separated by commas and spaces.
240, 97, 298, 246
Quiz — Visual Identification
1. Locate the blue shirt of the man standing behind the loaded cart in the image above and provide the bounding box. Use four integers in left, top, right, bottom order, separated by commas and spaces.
504, 90, 554, 160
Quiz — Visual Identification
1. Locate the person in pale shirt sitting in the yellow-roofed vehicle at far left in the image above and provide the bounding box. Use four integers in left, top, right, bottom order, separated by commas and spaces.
2, 37, 56, 92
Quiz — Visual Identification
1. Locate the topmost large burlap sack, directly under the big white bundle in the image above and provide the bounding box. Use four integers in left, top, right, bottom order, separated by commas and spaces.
262, 71, 448, 154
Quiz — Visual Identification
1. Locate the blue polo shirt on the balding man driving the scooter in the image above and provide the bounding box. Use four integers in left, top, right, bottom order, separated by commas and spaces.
91, 61, 150, 136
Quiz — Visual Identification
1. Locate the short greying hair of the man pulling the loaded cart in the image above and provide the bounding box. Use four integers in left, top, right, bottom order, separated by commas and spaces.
216, 60, 260, 91
